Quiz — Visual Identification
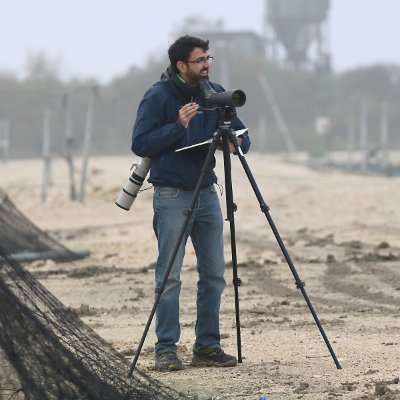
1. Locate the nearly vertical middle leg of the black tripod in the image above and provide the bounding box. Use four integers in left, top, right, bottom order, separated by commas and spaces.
222, 130, 242, 363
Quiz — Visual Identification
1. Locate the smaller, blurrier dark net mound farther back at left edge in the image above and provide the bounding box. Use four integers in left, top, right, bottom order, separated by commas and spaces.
0, 189, 82, 261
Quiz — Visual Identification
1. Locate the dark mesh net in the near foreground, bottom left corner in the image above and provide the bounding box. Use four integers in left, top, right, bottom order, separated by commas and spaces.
0, 243, 184, 400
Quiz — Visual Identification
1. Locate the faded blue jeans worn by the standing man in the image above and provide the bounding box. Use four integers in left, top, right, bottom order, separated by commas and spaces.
153, 186, 225, 353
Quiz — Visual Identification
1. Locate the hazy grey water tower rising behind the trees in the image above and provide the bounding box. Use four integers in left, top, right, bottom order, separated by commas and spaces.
264, 0, 330, 69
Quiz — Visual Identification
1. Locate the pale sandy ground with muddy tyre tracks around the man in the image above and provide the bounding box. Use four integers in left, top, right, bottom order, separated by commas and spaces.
0, 154, 400, 400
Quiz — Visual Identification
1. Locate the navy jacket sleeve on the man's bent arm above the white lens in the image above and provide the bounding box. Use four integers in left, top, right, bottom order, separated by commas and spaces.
132, 86, 186, 158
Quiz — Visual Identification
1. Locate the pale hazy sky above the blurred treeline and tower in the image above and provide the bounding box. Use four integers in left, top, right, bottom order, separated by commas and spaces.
0, 0, 400, 82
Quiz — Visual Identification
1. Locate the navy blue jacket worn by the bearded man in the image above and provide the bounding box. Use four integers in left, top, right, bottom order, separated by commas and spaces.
132, 75, 250, 190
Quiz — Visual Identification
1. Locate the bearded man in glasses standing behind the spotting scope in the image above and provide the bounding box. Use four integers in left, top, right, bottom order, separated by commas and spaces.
132, 36, 250, 371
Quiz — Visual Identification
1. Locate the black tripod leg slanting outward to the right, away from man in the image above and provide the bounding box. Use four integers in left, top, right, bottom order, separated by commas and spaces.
230, 132, 342, 369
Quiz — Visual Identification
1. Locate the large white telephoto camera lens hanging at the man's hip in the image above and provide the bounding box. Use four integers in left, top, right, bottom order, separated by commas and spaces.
115, 157, 151, 211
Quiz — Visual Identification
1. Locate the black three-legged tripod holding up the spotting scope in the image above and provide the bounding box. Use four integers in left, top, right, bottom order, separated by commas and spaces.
128, 106, 342, 378
